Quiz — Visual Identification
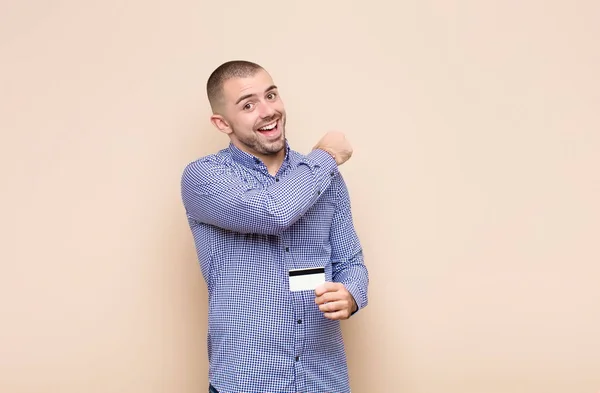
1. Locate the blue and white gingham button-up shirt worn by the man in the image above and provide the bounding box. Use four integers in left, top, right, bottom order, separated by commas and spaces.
181, 142, 368, 393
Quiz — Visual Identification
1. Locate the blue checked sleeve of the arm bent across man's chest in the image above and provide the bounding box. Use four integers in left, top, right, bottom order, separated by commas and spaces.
181, 149, 337, 235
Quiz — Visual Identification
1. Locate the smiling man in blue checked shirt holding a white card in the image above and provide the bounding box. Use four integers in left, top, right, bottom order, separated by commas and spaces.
181, 61, 368, 393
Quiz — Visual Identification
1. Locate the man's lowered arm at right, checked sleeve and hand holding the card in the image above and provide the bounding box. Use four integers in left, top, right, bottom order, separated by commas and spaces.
315, 173, 369, 319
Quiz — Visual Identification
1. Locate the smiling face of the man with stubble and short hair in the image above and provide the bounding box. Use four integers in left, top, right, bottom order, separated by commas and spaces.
211, 70, 286, 157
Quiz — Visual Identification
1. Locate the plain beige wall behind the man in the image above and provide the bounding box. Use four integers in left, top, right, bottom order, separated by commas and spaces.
0, 0, 600, 393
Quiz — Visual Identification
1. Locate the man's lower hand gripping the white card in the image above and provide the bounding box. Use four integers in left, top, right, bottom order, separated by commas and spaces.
315, 282, 358, 320
